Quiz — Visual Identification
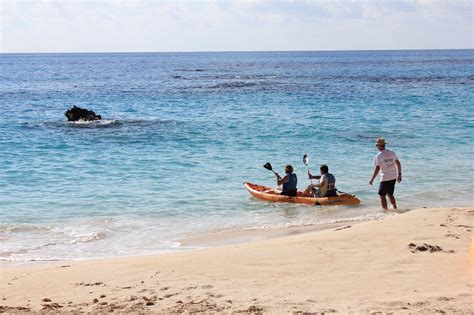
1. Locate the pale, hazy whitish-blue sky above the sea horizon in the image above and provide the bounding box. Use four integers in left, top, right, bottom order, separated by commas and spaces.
0, 0, 474, 53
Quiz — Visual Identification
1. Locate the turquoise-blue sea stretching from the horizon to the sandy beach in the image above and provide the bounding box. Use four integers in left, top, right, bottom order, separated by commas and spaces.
0, 50, 474, 261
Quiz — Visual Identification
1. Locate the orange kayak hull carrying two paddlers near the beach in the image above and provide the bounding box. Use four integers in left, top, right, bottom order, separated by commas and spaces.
244, 182, 360, 206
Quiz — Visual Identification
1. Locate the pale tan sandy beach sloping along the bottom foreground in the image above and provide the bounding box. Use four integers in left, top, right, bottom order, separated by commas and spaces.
0, 208, 474, 314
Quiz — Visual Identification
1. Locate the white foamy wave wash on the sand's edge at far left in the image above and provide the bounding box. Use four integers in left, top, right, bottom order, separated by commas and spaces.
0, 217, 190, 262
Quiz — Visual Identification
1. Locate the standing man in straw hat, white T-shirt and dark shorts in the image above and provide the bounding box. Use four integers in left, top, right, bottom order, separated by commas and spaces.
369, 137, 402, 210
